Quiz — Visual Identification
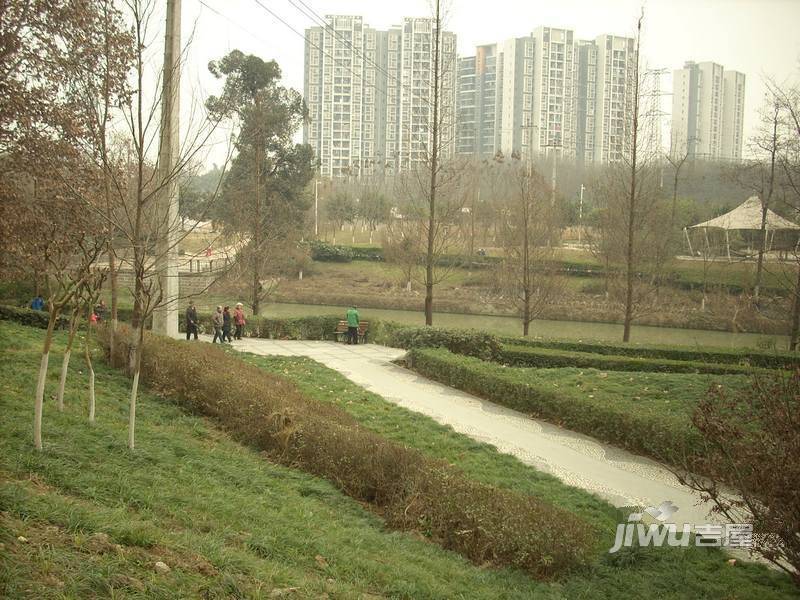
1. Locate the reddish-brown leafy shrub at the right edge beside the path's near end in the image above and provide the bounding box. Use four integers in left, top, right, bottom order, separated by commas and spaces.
681, 370, 800, 587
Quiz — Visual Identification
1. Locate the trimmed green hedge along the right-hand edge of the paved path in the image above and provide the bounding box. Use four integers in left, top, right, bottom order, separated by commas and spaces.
408, 349, 701, 464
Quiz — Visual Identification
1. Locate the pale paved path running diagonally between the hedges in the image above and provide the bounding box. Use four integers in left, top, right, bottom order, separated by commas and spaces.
227, 339, 719, 524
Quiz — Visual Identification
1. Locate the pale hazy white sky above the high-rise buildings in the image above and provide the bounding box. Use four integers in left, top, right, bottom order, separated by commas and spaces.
170, 0, 800, 167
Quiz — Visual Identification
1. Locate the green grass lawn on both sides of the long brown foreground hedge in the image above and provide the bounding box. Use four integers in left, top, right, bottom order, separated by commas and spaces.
0, 322, 796, 600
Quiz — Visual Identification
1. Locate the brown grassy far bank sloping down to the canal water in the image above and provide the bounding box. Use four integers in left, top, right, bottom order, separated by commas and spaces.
272, 261, 789, 335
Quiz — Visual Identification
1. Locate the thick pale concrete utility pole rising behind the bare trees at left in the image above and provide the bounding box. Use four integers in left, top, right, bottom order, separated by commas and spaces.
153, 0, 181, 337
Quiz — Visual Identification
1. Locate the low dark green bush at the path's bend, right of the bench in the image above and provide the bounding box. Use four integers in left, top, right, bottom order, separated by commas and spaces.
381, 326, 501, 360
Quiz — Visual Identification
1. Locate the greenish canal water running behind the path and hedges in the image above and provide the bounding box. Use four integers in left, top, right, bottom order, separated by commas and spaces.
261, 303, 788, 350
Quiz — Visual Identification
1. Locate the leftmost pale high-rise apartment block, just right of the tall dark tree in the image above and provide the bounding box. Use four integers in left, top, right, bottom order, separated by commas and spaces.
303, 15, 456, 176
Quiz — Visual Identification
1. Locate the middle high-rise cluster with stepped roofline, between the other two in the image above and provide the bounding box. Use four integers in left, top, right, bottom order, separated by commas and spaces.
457, 27, 635, 162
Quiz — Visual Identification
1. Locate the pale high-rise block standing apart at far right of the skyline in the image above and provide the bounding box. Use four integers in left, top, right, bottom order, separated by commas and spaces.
670, 61, 744, 160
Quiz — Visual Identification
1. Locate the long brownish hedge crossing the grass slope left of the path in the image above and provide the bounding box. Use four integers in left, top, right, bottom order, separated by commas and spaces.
101, 332, 597, 579
